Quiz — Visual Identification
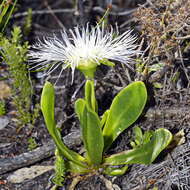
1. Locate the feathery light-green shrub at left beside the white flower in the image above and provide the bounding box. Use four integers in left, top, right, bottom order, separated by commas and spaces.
0, 27, 39, 126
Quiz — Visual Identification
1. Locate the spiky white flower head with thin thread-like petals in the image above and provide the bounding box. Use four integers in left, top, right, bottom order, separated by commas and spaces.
29, 26, 138, 81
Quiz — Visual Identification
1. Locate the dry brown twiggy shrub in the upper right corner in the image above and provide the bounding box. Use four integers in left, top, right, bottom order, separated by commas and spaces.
135, 0, 190, 60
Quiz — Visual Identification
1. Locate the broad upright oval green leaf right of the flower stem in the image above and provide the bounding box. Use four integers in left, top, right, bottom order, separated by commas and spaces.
103, 81, 147, 150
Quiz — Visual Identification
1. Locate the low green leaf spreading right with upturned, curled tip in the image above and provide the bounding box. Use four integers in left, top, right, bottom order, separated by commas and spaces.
104, 128, 172, 165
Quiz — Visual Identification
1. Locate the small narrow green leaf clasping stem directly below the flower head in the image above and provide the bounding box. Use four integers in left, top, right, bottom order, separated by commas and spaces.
85, 80, 98, 112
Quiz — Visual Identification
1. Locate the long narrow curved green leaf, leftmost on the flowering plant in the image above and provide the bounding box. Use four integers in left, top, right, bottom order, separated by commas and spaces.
41, 82, 85, 166
